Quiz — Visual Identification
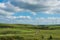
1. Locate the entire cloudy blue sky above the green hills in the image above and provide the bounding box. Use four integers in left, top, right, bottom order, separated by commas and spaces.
0, 0, 60, 25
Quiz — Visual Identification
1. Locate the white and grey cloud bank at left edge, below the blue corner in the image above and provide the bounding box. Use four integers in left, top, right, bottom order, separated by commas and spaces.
0, 2, 23, 18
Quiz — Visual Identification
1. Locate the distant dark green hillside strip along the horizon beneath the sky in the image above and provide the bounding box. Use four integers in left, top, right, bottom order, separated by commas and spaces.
0, 24, 60, 29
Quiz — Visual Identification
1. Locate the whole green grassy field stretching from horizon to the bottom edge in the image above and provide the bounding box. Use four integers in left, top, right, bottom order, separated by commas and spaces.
0, 24, 60, 40
